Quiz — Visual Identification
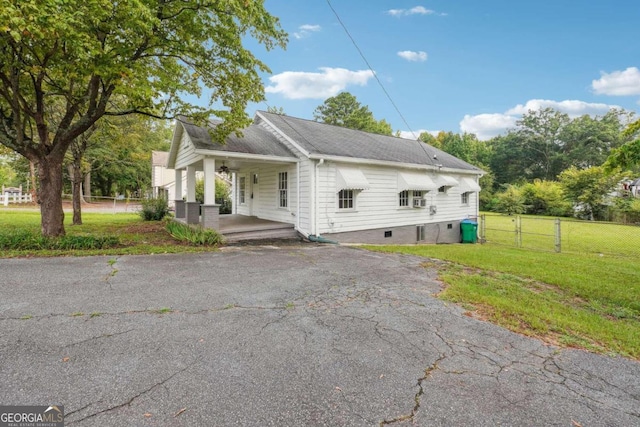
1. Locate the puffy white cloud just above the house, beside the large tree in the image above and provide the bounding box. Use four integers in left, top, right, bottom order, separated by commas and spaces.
265, 67, 373, 99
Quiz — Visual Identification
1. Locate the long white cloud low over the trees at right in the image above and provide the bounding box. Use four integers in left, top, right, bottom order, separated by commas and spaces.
460, 99, 620, 141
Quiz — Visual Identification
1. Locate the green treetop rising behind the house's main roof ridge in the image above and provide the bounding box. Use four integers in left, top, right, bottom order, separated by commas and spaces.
313, 92, 393, 135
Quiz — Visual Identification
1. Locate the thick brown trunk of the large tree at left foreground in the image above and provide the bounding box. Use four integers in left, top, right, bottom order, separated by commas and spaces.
38, 156, 64, 237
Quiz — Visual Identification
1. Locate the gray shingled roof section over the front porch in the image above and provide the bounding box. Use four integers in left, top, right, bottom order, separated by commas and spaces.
181, 121, 295, 157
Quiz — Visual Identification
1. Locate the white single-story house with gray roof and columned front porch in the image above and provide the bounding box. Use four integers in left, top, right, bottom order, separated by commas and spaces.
167, 111, 483, 244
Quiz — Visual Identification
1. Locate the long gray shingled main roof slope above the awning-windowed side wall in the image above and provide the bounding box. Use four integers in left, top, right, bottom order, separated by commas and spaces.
260, 111, 481, 172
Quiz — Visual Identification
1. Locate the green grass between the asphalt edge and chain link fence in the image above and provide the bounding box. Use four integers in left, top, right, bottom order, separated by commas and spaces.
366, 244, 640, 359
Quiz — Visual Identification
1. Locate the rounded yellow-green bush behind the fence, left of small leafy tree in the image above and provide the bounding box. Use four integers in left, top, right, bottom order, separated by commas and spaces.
520, 179, 573, 216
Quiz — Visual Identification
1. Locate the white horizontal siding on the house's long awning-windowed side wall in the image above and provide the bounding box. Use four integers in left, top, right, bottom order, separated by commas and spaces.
318, 163, 477, 234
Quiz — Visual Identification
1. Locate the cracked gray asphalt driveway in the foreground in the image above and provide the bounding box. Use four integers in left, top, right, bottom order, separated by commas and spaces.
0, 245, 640, 427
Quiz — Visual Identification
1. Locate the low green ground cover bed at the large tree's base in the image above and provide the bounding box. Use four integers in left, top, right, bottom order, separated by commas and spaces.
0, 229, 120, 251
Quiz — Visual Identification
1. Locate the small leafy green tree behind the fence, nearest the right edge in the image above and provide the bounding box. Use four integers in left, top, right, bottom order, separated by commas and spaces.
560, 166, 621, 220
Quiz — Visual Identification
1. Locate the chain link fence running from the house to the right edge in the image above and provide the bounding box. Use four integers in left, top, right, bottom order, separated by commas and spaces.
478, 214, 640, 257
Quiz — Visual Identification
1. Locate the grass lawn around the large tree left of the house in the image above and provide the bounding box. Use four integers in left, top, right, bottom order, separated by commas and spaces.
0, 209, 216, 258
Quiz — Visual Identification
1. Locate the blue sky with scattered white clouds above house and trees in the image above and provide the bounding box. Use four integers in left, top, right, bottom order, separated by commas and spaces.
239, 0, 640, 139
